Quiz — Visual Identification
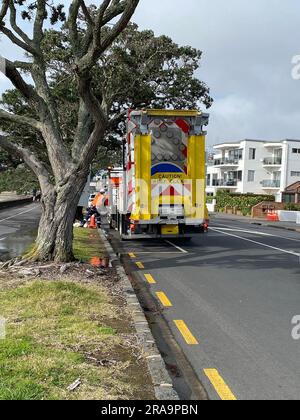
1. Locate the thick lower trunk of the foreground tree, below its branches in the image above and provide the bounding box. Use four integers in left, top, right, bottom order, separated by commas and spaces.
26, 170, 89, 262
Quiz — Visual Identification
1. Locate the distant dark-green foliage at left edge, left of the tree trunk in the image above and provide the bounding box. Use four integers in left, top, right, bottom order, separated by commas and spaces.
0, 165, 39, 194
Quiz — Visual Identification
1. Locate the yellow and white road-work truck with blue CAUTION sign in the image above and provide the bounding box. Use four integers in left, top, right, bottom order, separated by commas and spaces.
108, 109, 209, 239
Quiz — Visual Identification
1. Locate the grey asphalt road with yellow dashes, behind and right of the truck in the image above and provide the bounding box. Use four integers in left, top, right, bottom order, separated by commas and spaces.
111, 218, 300, 400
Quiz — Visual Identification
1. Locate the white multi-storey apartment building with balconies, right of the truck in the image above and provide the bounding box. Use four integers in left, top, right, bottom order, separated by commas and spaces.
207, 140, 300, 201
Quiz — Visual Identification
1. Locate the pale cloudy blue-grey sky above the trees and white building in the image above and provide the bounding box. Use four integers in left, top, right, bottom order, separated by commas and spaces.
0, 0, 300, 146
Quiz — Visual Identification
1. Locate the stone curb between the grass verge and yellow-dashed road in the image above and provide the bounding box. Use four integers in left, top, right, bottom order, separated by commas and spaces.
99, 229, 179, 401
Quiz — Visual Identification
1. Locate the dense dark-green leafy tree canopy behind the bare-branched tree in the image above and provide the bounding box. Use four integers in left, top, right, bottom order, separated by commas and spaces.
0, 20, 212, 184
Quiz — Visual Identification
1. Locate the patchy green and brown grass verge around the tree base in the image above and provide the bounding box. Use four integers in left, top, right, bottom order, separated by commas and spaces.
0, 229, 154, 400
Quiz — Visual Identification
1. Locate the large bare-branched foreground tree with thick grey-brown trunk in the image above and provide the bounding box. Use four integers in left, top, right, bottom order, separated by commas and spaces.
0, 0, 139, 262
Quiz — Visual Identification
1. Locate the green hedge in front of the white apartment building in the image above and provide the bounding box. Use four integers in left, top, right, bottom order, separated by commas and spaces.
216, 190, 275, 216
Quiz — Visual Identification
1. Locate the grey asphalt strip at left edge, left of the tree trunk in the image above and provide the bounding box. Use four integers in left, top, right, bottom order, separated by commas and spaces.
0, 204, 41, 261
